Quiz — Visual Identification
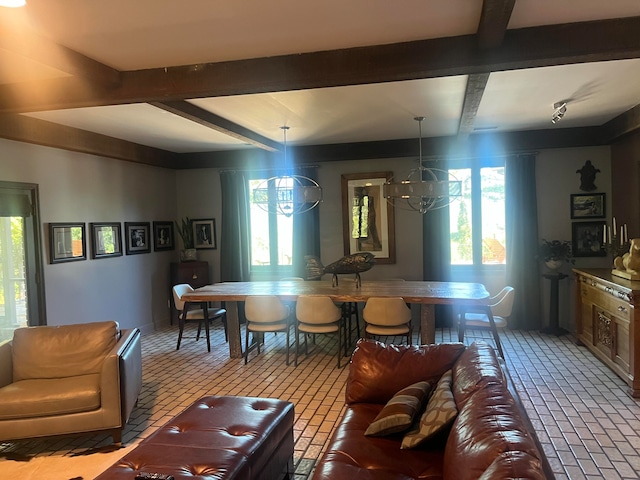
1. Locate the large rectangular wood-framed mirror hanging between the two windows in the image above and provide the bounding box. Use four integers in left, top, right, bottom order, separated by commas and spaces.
342, 172, 396, 264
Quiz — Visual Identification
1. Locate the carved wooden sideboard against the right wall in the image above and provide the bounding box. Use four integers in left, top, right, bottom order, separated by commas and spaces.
573, 268, 640, 398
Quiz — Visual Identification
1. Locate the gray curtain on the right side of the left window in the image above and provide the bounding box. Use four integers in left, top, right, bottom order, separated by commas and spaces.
292, 167, 320, 278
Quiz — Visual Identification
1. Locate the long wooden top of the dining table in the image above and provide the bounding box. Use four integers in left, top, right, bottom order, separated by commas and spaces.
183, 279, 489, 304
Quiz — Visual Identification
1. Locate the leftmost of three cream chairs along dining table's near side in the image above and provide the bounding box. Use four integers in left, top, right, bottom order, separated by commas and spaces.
244, 295, 291, 365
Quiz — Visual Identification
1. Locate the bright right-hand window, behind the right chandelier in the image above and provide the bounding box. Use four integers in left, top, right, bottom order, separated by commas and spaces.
449, 159, 507, 266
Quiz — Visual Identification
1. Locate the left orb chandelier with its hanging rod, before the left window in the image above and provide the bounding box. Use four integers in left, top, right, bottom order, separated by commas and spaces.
253, 125, 322, 217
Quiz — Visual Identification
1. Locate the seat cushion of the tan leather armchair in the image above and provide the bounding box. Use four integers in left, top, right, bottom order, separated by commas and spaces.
0, 374, 100, 420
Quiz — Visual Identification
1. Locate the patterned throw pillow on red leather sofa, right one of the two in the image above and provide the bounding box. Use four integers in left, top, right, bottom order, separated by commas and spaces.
400, 370, 458, 449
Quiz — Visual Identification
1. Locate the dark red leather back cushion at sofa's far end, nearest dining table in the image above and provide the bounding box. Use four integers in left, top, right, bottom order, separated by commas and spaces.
345, 339, 465, 405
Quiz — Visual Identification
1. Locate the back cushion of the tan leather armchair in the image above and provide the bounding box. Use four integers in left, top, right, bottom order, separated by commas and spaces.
12, 321, 118, 382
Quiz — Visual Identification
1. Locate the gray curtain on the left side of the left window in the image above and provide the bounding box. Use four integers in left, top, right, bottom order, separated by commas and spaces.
220, 171, 251, 282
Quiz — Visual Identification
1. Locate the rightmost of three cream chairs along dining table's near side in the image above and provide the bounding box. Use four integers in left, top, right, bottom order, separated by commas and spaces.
362, 297, 412, 345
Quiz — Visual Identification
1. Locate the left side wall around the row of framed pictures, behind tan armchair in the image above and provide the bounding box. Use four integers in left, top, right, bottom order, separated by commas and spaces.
0, 140, 178, 329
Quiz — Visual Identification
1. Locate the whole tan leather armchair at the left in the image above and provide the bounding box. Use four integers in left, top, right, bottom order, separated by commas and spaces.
0, 321, 142, 444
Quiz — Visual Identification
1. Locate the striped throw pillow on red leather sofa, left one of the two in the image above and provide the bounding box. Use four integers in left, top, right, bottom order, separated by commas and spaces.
364, 382, 431, 436
